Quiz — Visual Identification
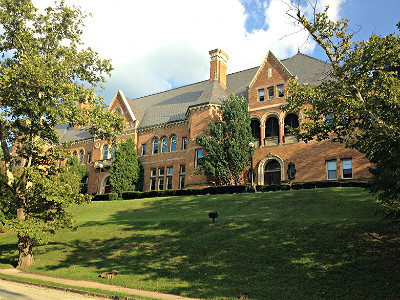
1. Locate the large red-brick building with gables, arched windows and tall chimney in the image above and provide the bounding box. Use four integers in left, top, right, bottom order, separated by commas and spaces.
58, 49, 370, 194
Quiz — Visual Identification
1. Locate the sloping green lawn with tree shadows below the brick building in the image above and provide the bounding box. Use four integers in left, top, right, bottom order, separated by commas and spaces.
0, 188, 400, 300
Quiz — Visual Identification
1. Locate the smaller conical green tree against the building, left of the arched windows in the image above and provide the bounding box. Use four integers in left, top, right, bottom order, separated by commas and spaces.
110, 137, 139, 196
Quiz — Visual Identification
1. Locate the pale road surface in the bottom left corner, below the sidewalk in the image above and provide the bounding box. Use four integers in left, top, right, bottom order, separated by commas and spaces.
0, 279, 105, 300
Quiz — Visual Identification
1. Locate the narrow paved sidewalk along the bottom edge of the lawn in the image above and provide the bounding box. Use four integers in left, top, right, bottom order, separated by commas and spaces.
0, 269, 200, 300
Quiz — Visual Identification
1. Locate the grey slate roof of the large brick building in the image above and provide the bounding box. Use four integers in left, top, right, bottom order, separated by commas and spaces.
59, 53, 331, 142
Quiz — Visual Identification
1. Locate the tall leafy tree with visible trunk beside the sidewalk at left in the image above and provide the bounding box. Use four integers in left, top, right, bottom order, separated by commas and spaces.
0, 0, 123, 267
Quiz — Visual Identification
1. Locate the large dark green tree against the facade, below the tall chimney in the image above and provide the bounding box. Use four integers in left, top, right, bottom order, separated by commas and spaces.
196, 94, 253, 185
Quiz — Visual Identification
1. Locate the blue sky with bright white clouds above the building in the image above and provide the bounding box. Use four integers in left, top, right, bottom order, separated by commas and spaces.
33, 0, 400, 103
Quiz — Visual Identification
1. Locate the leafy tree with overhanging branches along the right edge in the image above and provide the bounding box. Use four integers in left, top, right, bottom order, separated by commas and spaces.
284, 7, 400, 214
